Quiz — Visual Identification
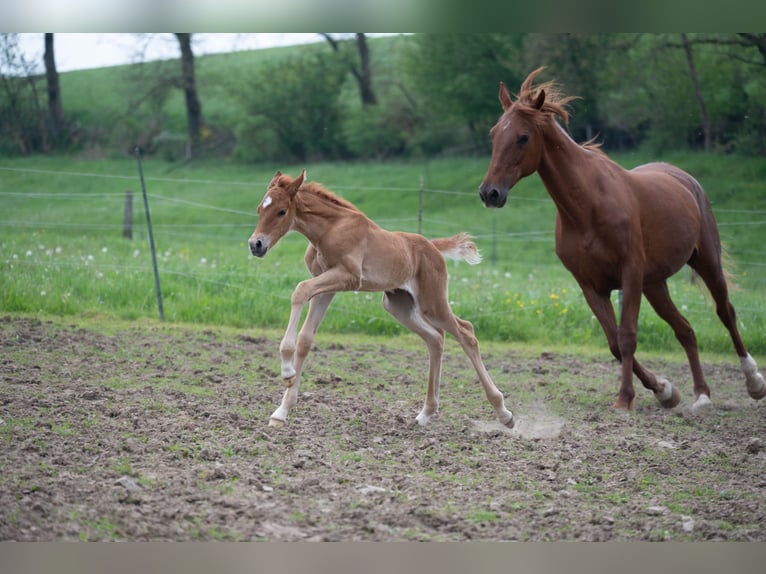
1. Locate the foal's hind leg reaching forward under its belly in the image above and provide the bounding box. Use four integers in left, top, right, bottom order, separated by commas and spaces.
383, 289, 444, 426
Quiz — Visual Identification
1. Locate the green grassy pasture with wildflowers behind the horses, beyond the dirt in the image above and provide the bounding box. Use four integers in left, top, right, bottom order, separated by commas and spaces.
0, 153, 766, 354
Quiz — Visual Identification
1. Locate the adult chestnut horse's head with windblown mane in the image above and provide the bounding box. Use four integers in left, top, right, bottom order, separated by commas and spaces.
479, 68, 574, 207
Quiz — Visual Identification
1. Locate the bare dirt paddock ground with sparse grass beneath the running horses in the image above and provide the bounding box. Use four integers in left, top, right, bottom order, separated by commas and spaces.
0, 317, 766, 541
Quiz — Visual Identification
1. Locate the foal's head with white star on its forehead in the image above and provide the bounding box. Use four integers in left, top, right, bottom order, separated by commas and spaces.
249, 169, 306, 257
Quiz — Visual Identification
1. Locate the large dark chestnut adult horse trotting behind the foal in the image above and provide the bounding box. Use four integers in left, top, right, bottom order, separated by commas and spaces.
479, 68, 766, 409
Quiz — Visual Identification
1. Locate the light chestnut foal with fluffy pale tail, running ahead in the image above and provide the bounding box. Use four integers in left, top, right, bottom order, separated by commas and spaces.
249, 170, 514, 427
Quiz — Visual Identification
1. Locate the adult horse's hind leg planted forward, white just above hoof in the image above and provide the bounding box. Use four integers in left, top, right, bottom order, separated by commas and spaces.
644, 281, 712, 409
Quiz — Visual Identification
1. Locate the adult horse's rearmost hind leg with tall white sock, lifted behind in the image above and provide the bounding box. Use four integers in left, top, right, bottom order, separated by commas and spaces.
690, 254, 766, 400
